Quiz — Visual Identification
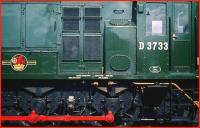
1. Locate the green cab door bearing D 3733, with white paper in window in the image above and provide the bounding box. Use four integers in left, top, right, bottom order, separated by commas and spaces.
137, 2, 170, 75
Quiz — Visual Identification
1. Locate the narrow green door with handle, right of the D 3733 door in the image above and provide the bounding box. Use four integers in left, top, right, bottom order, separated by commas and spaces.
170, 2, 192, 72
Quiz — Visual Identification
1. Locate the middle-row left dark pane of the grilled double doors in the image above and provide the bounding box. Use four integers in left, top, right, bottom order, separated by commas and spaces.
63, 19, 79, 33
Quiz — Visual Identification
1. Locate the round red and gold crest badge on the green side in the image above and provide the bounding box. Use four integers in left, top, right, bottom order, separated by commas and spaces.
10, 54, 27, 71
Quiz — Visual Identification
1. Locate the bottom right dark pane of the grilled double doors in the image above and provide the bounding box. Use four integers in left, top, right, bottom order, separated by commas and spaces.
84, 36, 100, 60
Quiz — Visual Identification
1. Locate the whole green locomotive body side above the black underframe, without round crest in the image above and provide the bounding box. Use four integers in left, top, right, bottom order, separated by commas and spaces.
2, 2, 197, 79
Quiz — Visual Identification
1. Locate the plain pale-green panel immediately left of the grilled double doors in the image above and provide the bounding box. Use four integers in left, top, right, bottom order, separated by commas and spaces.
26, 3, 59, 48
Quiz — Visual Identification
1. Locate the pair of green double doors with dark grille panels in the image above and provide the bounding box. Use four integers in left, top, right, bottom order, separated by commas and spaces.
59, 5, 103, 75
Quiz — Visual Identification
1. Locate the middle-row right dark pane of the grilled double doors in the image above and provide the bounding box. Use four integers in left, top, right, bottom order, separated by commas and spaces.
85, 19, 100, 33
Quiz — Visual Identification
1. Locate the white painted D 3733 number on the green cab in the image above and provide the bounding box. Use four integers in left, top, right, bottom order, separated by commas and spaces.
139, 42, 168, 51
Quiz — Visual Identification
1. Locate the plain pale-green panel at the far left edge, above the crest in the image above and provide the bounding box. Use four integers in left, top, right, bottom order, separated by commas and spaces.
2, 3, 22, 48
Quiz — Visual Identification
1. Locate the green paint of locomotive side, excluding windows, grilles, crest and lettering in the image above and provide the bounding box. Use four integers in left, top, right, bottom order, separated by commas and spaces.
2, 2, 198, 79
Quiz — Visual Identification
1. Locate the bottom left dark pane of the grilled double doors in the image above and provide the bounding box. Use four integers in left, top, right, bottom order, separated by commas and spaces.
63, 36, 79, 60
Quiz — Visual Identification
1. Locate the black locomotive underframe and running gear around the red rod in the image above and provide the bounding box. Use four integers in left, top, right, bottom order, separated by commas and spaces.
2, 80, 198, 126
